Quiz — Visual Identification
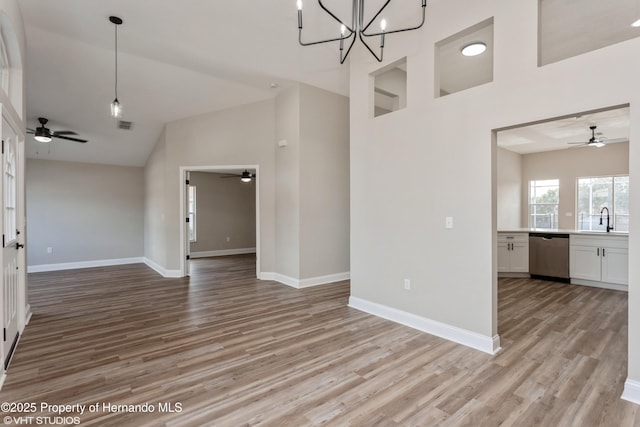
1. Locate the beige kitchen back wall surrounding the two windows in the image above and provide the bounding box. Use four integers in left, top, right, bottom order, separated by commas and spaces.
521, 142, 629, 229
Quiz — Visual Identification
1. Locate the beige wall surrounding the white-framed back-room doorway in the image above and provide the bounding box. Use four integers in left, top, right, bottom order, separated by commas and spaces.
154, 100, 276, 274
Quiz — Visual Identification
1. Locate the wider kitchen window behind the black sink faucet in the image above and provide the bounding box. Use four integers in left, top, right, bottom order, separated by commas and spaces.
577, 175, 629, 232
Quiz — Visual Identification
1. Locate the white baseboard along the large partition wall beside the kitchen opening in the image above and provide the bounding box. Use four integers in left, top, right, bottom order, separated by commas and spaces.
349, 296, 500, 354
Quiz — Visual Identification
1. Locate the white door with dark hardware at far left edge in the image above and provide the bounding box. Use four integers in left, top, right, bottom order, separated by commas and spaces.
2, 118, 23, 369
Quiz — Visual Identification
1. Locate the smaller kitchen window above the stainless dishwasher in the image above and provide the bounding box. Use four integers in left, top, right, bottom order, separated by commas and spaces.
529, 179, 560, 229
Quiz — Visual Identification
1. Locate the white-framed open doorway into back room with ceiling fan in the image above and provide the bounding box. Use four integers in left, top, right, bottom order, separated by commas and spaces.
180, 165, 260, 278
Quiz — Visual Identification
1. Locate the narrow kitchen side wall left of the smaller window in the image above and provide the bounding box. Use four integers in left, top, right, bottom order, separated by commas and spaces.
496, 148, 527, 230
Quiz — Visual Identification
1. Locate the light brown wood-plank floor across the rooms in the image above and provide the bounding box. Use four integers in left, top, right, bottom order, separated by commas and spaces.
0, 255, 640, 427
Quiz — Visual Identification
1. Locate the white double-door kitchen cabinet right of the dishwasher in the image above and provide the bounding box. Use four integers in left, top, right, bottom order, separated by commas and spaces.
569, 234, 629, 289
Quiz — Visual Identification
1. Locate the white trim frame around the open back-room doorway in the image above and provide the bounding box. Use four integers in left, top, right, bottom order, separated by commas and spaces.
179, 164, 261, 279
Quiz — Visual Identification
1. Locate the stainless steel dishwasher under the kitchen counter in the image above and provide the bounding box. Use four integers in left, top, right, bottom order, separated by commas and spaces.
529, 233, 569, 281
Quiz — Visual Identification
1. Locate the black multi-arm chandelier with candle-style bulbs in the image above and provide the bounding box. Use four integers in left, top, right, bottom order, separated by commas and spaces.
297, 0, 427, 64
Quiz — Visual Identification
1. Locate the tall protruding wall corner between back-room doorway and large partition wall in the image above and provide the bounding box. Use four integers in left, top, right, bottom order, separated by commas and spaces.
276, 84, 349, 283
